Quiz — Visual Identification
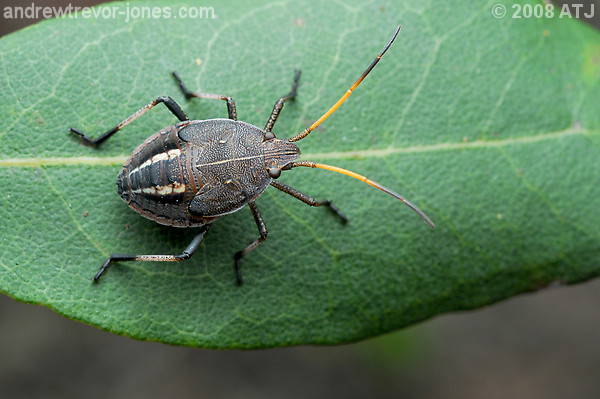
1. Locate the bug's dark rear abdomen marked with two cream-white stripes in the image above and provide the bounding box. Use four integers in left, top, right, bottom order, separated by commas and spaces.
117, 122, 212, 227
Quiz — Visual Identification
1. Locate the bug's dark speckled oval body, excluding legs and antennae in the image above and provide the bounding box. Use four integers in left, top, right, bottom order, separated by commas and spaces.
117, 119, 300, 227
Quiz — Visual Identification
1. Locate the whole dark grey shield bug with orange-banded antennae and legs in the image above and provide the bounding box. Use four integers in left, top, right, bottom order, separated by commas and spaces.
71, 26, 434, 284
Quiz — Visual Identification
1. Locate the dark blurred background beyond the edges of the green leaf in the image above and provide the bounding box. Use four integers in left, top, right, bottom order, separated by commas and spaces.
0, 0, 600, 399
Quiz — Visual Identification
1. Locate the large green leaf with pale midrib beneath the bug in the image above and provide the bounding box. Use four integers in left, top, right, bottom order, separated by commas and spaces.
0, 0, 600, 348
